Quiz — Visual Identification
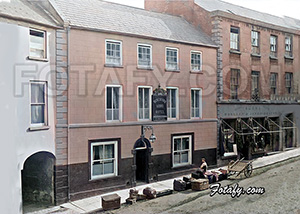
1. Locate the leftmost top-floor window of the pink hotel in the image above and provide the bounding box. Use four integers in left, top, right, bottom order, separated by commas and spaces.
105, 40, 122, 66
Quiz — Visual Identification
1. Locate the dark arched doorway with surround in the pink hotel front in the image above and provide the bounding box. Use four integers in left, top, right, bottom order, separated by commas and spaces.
132, 138, 153, 186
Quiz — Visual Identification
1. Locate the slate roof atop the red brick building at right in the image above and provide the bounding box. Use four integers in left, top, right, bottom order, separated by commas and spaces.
195, 0, 300, 29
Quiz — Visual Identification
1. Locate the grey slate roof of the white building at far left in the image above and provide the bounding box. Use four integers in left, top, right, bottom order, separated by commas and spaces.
0, 0, 57, 26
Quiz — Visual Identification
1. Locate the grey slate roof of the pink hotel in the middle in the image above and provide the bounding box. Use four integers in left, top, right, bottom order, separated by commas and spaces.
51, 0, 215, 46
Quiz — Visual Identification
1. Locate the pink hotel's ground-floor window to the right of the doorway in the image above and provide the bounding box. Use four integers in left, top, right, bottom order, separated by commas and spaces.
172, 135, 192, 167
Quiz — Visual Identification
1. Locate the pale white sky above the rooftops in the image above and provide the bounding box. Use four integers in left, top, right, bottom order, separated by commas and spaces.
106, 0, 300, 19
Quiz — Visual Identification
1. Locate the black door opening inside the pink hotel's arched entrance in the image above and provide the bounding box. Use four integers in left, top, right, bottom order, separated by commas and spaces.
136, 149, 148, 182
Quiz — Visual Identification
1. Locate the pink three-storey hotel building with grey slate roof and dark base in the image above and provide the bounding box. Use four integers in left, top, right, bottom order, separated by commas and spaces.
54, 0, 217, 200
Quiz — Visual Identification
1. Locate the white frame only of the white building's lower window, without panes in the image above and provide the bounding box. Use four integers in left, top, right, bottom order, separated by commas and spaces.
29, 80, 48, 128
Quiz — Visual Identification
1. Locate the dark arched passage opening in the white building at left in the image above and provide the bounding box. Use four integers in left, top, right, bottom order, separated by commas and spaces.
21, 152, 55, 213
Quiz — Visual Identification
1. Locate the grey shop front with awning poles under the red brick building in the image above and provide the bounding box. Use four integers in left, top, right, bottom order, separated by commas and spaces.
219, 104, 299, 159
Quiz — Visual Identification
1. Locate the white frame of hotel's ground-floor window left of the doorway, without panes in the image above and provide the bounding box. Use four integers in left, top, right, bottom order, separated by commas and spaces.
90, 141, 118, 180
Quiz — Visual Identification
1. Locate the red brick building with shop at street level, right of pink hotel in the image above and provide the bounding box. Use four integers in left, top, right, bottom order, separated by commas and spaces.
145, 0, 300, 162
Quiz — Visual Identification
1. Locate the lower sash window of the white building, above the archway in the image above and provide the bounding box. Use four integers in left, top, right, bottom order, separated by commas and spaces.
30, 81, 47, 127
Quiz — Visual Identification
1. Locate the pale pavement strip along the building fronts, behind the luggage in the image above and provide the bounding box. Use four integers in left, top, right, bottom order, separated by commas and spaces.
31, 148, 300, 214
